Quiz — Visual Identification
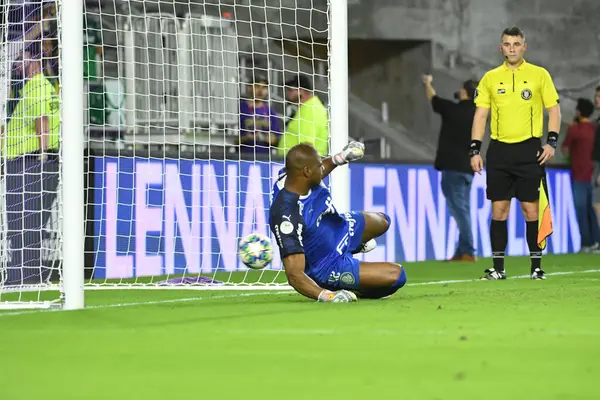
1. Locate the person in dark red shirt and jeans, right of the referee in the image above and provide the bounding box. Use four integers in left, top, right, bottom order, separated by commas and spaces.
562, 99, 600, 253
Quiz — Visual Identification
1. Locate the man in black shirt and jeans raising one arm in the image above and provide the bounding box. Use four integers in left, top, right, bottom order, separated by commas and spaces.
423, 75, 477, 261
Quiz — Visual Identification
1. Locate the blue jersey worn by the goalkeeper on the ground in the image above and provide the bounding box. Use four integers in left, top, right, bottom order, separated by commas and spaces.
269, 173, 360, 277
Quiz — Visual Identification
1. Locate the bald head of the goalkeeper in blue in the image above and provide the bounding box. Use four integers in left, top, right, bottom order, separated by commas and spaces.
285, 143, 322, 189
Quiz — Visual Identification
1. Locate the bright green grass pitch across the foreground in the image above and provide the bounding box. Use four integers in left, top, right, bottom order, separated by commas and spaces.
0, 255, 600, 400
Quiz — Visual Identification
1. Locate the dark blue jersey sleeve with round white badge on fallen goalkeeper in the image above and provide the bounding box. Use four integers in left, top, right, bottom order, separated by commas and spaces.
271, 198, 305, 259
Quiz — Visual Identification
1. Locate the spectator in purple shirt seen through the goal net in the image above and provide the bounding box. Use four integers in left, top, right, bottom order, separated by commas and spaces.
240, 76, 281, 153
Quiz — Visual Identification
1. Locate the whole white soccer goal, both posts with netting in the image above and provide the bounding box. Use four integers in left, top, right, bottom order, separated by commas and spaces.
0, 0, 350, 310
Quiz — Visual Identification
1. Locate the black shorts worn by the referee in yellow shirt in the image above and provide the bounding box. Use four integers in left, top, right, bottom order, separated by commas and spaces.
486, 138, 546, 202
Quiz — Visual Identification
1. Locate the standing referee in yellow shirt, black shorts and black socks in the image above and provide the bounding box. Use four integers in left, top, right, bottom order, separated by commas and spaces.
469, 27, 561, 280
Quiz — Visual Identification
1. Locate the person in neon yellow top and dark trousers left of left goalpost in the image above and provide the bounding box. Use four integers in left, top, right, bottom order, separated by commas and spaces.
0, 42, 60, 284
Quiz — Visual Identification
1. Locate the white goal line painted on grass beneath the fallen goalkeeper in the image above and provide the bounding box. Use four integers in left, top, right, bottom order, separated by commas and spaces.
0, 269, 600, 318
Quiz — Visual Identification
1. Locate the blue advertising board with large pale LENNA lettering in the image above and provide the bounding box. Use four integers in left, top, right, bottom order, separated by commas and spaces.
93, 157, 580, 278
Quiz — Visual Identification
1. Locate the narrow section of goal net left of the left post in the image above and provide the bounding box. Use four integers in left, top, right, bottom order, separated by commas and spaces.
0, 1, 62, 309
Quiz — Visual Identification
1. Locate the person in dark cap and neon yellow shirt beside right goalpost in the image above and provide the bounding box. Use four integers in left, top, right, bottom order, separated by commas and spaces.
278, 75, 329, 157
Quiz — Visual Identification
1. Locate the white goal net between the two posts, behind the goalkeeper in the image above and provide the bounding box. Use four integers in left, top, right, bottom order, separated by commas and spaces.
84, 0, 330, 289
